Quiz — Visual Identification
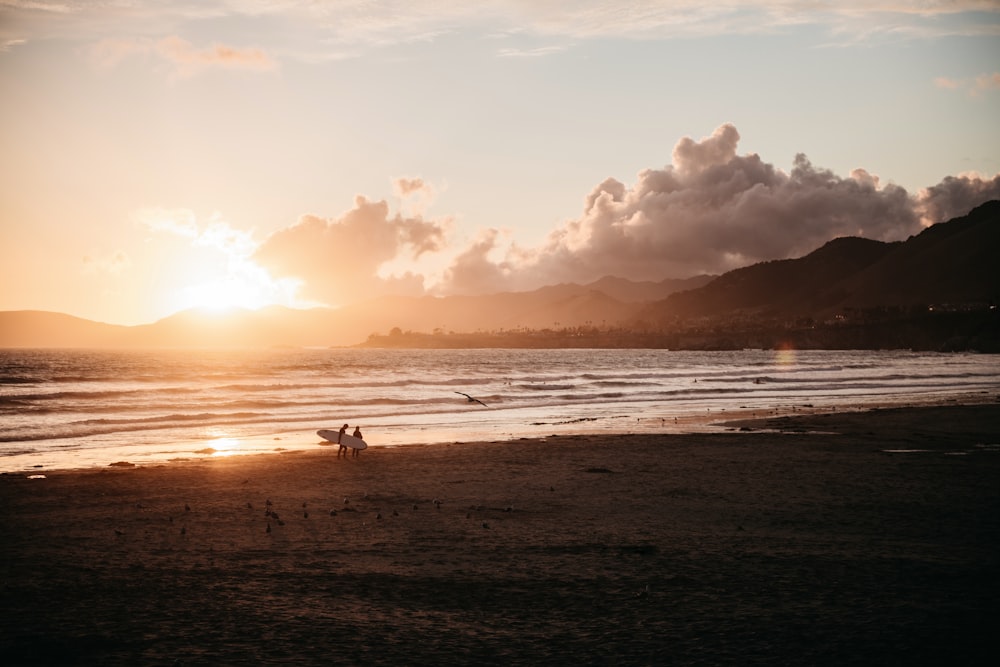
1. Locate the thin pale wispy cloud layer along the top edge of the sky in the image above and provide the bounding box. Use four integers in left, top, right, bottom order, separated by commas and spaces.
0, 0, 1000, 60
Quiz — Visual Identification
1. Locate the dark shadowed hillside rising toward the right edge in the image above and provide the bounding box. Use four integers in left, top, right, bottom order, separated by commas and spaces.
638, 201, 1000, 323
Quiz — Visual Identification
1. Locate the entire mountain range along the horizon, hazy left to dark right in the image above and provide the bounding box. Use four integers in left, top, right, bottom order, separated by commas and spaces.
0, 201, 1000, 348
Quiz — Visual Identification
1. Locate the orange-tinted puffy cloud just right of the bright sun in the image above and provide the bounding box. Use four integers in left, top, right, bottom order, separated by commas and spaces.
254, 194, 446, 305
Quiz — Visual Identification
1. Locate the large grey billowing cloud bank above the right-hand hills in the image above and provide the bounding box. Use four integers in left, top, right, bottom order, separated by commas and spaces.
439, 124, 1000, 293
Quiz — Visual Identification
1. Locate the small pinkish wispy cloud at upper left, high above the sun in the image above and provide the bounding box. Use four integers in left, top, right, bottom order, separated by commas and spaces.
90, 36, 277, 77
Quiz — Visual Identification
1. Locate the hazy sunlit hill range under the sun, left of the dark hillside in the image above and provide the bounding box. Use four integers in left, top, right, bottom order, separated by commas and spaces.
0, 277, 711, 348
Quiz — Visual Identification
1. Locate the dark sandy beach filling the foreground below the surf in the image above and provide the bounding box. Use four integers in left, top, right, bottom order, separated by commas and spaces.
0, 404, 1000, 665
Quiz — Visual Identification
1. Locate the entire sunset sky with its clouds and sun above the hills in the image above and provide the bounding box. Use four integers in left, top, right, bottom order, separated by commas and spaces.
0, 0, 1000, 325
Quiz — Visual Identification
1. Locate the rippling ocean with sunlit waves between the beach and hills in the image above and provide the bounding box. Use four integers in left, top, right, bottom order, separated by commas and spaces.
0, 349, 1000, 472
